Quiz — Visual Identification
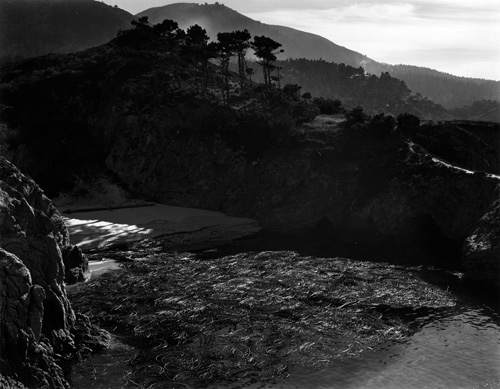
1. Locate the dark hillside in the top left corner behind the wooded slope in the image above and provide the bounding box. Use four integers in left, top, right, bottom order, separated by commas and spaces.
0, 0, 133, 59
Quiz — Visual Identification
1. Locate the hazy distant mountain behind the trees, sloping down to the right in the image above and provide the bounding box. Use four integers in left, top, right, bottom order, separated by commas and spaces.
136, 3, 500, 109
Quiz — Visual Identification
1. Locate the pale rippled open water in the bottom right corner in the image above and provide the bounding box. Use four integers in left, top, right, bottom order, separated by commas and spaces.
233, 306, 500, 389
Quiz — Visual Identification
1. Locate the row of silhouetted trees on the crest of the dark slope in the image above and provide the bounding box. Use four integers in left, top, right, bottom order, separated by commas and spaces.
117, 16, 283, 102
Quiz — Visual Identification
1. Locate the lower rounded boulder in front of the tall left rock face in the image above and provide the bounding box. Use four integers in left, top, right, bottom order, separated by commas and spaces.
0, 248, 69, 388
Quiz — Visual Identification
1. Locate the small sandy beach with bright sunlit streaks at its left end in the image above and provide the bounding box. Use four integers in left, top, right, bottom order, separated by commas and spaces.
62, 203, 260, 250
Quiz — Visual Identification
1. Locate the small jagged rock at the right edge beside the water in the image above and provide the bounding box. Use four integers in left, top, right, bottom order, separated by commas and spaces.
464, 200, 500, 289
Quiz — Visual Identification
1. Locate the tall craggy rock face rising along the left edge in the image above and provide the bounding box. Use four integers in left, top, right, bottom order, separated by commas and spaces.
0, 158, 88, 388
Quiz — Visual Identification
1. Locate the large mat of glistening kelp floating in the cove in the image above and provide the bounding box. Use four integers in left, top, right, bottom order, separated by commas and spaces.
68, 251, 454, 389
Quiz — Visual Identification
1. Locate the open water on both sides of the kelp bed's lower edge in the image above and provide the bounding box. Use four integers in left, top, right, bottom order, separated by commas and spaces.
70, 264, 500, 389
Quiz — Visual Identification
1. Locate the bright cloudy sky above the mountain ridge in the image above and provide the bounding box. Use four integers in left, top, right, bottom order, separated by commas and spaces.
104, 0, 500, 80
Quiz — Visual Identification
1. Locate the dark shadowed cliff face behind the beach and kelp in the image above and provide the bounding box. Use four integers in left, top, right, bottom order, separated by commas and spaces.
108, 124, 499, 266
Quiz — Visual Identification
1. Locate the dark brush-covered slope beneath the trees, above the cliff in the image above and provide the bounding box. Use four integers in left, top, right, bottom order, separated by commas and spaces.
0, 18, 324, 194
